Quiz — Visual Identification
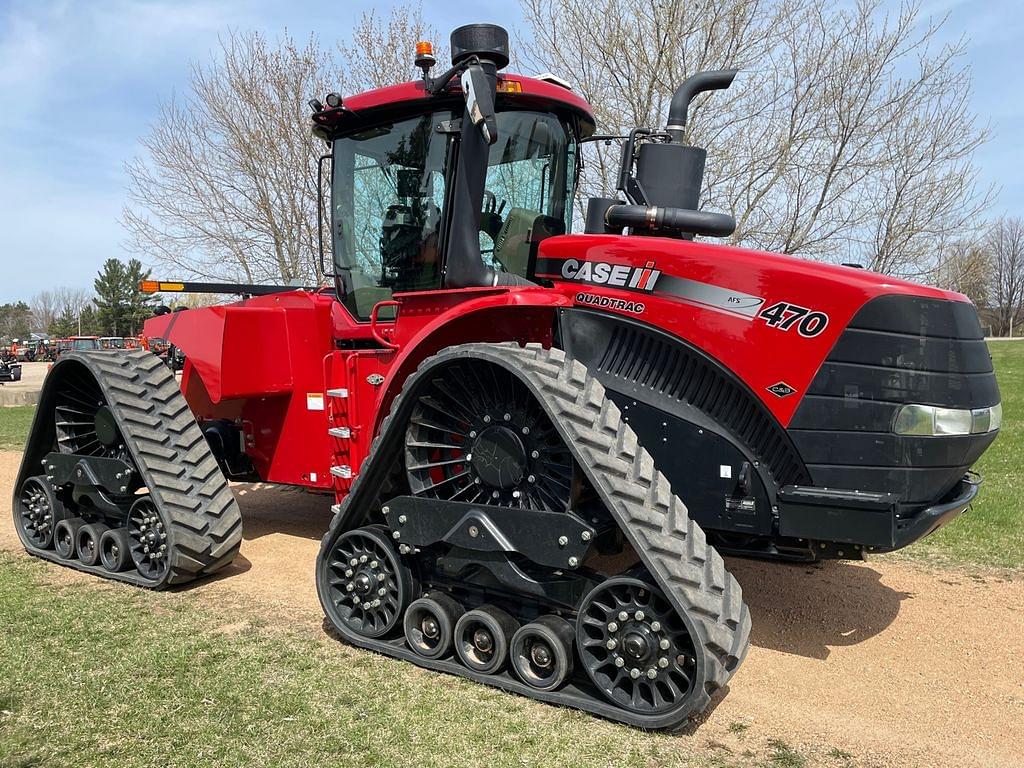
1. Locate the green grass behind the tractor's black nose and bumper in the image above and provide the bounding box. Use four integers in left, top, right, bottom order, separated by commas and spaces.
902, 341, 1024, 568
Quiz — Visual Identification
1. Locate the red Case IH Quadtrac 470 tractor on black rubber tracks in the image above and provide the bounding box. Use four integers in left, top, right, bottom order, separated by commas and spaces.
14, 25, 1000, 728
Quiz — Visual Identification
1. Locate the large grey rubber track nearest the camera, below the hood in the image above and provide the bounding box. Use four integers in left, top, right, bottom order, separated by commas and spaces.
317, 344, 751, 728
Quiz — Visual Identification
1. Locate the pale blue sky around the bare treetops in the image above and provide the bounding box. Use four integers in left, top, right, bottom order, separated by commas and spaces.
0, 0, 1024, 302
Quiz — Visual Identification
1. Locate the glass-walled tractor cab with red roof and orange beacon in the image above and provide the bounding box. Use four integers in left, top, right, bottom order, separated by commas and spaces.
312, 27, 594, 321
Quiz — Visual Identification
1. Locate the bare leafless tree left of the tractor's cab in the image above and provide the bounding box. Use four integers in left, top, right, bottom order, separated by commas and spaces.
123, 8, 433, 284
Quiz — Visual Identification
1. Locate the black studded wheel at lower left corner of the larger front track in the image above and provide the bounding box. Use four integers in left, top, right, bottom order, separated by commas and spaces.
329, 525, 415, 638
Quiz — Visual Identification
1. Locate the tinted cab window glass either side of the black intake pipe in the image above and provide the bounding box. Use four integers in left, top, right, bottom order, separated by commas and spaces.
331, 111, 577, 319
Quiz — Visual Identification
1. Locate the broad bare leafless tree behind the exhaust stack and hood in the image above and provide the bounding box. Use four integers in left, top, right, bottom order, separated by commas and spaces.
520, 0, 988, 275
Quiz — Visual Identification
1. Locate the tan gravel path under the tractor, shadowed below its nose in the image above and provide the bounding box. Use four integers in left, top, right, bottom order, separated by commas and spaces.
0, 452, 1024, 768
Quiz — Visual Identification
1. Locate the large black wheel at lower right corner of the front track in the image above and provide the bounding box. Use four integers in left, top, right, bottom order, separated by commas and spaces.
577, 577, 696, 715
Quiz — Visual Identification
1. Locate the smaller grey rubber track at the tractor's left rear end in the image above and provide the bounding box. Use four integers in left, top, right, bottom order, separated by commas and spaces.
14, 350, 242, 589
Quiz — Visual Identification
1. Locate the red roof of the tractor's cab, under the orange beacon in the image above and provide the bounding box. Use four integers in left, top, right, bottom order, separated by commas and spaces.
314, 74, 594, 137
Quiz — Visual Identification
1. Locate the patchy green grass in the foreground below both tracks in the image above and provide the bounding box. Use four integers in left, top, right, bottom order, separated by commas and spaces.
0, 552, 737, 768
